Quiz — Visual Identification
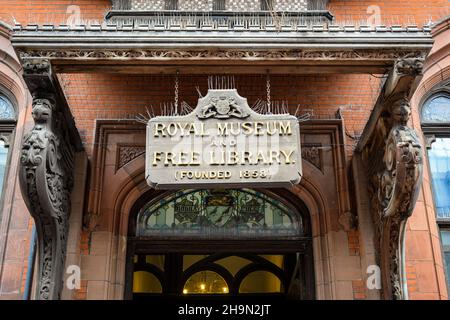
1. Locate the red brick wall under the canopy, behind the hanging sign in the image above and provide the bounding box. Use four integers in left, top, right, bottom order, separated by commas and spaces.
60, 74, 380, 156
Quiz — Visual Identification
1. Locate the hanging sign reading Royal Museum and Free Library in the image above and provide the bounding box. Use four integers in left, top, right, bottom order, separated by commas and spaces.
146, 89, 302, 189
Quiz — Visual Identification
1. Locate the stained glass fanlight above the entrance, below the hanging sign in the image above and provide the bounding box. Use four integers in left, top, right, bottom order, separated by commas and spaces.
136, 189, 303, 239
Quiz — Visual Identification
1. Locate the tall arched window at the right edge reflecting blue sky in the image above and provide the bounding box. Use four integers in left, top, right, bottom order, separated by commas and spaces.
421, 85, 450, 298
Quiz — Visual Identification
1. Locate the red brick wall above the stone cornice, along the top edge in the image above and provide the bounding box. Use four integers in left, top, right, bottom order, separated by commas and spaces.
0, 0, 450, 25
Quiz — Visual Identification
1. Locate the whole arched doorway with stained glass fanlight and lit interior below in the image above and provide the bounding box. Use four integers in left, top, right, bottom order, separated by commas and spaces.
125, 189, 314, 299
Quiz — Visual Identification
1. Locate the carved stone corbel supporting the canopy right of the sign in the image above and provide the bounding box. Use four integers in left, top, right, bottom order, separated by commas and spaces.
357, 58, 423, 299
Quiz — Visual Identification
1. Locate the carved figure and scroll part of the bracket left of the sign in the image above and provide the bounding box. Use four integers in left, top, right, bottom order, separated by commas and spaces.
20, 99, 74, 300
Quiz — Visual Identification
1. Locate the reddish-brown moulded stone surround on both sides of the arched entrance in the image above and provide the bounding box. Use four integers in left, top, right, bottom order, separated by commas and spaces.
84, 119, 352, 299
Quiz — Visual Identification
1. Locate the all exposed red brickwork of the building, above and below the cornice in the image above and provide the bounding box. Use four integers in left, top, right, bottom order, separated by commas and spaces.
0, 0, 450, 299
